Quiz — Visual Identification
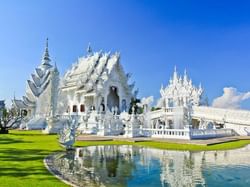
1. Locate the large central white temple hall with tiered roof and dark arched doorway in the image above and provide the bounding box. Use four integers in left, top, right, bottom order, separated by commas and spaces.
58, 46, 134, 114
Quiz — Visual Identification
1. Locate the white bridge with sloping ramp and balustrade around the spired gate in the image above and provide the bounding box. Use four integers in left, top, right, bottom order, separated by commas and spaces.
147, 106, 250, 139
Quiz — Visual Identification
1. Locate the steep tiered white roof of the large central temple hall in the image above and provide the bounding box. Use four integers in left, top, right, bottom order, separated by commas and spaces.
62, 46, 134, 93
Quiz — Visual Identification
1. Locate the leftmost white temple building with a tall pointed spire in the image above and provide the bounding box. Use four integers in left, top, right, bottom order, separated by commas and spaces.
13, 39, 59, 129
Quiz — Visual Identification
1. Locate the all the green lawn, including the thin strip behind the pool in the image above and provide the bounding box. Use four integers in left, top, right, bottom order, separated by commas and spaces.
0, 131, 250, 187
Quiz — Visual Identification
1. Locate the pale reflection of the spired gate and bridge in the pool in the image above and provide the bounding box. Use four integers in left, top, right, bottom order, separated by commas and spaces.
140, 146, 250, 186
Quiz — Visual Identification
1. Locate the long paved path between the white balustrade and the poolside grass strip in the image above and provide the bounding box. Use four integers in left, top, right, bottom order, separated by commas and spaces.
77, 135, 250, 145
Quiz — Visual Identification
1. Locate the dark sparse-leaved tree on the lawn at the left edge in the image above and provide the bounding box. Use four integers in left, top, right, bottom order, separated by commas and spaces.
0, 108, 24, 134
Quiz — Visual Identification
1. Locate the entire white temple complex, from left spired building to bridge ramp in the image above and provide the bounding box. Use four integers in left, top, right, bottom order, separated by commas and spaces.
13, 41, 250, 139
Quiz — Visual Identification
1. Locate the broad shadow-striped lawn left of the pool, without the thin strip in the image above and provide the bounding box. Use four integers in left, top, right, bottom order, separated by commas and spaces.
0, 131, 67, 187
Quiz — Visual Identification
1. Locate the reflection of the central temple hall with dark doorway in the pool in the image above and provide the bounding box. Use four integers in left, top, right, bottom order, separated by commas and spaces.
75, 146, 136, 186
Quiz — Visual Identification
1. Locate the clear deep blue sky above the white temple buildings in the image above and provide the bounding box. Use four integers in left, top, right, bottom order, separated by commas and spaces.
0, 0, 250, 108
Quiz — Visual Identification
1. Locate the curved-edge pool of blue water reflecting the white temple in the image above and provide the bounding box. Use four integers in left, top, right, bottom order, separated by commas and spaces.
47, 145, 250, 187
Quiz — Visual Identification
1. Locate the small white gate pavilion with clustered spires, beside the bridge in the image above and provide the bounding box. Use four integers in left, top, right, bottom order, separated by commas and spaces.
158, 67, 203, 129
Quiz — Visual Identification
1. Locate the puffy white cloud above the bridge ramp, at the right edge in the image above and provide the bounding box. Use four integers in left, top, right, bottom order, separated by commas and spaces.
212, 87, 250, 109
